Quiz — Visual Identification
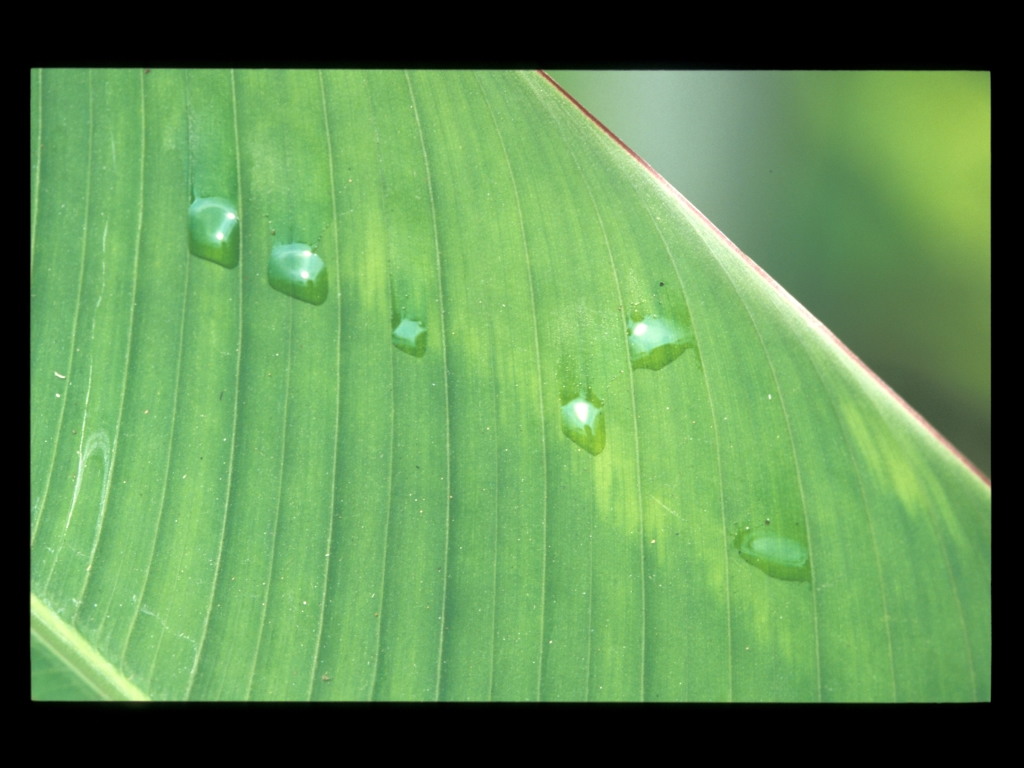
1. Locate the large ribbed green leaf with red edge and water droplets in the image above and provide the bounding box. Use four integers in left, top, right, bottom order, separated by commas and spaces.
31, 70, 991, 700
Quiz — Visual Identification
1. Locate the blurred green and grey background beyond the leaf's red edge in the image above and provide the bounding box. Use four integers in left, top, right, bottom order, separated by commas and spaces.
549, 71, 991, 476
